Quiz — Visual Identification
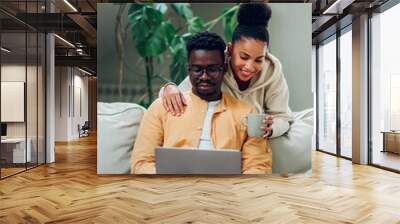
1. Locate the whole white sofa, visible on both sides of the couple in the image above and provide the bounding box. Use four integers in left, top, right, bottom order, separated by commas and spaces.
97, 102, 313, 174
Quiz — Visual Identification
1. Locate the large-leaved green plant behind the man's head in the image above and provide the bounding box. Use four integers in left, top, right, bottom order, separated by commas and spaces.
128, 3, 238, 107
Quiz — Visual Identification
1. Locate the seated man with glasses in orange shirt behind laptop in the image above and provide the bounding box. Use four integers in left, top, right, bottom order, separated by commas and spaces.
131, 32, 272, 174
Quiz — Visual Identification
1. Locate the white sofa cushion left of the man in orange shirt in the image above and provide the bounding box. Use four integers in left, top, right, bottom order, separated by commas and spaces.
97, 102, 146, 174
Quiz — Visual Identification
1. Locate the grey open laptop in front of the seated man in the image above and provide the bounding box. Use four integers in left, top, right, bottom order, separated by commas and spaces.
156, 147, 242, 174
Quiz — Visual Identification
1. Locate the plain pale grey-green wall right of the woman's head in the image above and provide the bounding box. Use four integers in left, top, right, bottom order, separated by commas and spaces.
268, 3, 313, 111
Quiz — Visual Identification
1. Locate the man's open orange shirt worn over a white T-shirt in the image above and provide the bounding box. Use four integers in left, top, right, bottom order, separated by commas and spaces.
131, 92, 272, 174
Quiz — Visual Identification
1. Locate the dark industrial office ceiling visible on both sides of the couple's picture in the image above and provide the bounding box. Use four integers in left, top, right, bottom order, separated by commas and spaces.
0, 0, 394, 75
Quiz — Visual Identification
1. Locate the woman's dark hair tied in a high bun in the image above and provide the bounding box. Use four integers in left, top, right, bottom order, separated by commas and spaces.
232, 3, 272, 43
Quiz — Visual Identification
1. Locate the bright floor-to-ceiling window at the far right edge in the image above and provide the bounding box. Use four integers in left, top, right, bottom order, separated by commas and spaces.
370, 4, 400, 170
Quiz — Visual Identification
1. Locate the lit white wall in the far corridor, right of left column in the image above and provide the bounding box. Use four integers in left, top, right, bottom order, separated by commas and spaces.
55, 67, 89, 141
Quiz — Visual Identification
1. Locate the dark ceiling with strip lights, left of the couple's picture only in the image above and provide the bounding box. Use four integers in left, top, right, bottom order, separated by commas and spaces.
0, 0, 97, 74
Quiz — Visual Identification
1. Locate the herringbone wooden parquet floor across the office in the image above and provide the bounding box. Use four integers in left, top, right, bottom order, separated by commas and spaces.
0, 134, 400, 224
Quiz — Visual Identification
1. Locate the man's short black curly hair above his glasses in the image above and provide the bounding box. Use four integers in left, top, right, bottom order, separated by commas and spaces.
186, 31, 226, 61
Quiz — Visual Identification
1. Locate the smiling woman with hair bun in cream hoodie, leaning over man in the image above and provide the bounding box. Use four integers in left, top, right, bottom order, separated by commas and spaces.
160, 3, 292, 138
